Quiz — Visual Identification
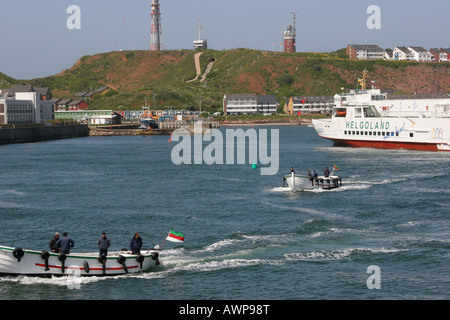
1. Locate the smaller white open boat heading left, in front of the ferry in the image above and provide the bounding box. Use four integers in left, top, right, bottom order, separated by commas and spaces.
283, 170, 342, 191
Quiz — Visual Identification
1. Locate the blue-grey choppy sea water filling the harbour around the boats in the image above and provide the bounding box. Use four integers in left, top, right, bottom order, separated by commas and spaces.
0, 126, 450, 300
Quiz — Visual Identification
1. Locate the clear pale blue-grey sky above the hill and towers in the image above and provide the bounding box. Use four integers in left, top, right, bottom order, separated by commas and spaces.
0, 0, 450, 80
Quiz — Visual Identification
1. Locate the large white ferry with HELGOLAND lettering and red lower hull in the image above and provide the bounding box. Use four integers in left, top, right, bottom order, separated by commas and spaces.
313, 71, 450, 151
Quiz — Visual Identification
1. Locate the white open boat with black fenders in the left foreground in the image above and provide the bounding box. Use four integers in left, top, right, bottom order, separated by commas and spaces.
0, 246, 161, 276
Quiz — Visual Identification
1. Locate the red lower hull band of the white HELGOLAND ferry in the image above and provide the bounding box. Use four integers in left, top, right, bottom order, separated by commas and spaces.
330, 139, 440, 151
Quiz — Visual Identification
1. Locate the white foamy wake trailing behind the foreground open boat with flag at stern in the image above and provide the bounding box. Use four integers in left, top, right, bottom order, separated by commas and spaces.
0, 228, 418, 288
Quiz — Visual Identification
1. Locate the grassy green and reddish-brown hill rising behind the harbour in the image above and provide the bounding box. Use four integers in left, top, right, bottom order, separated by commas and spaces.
10, 49, 450, 111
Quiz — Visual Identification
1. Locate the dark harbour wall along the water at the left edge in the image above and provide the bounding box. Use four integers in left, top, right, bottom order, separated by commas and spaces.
0, 125, 89, 145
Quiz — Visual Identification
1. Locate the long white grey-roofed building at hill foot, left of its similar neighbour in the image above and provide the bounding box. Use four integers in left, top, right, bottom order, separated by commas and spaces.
223, 93, 278, 115
